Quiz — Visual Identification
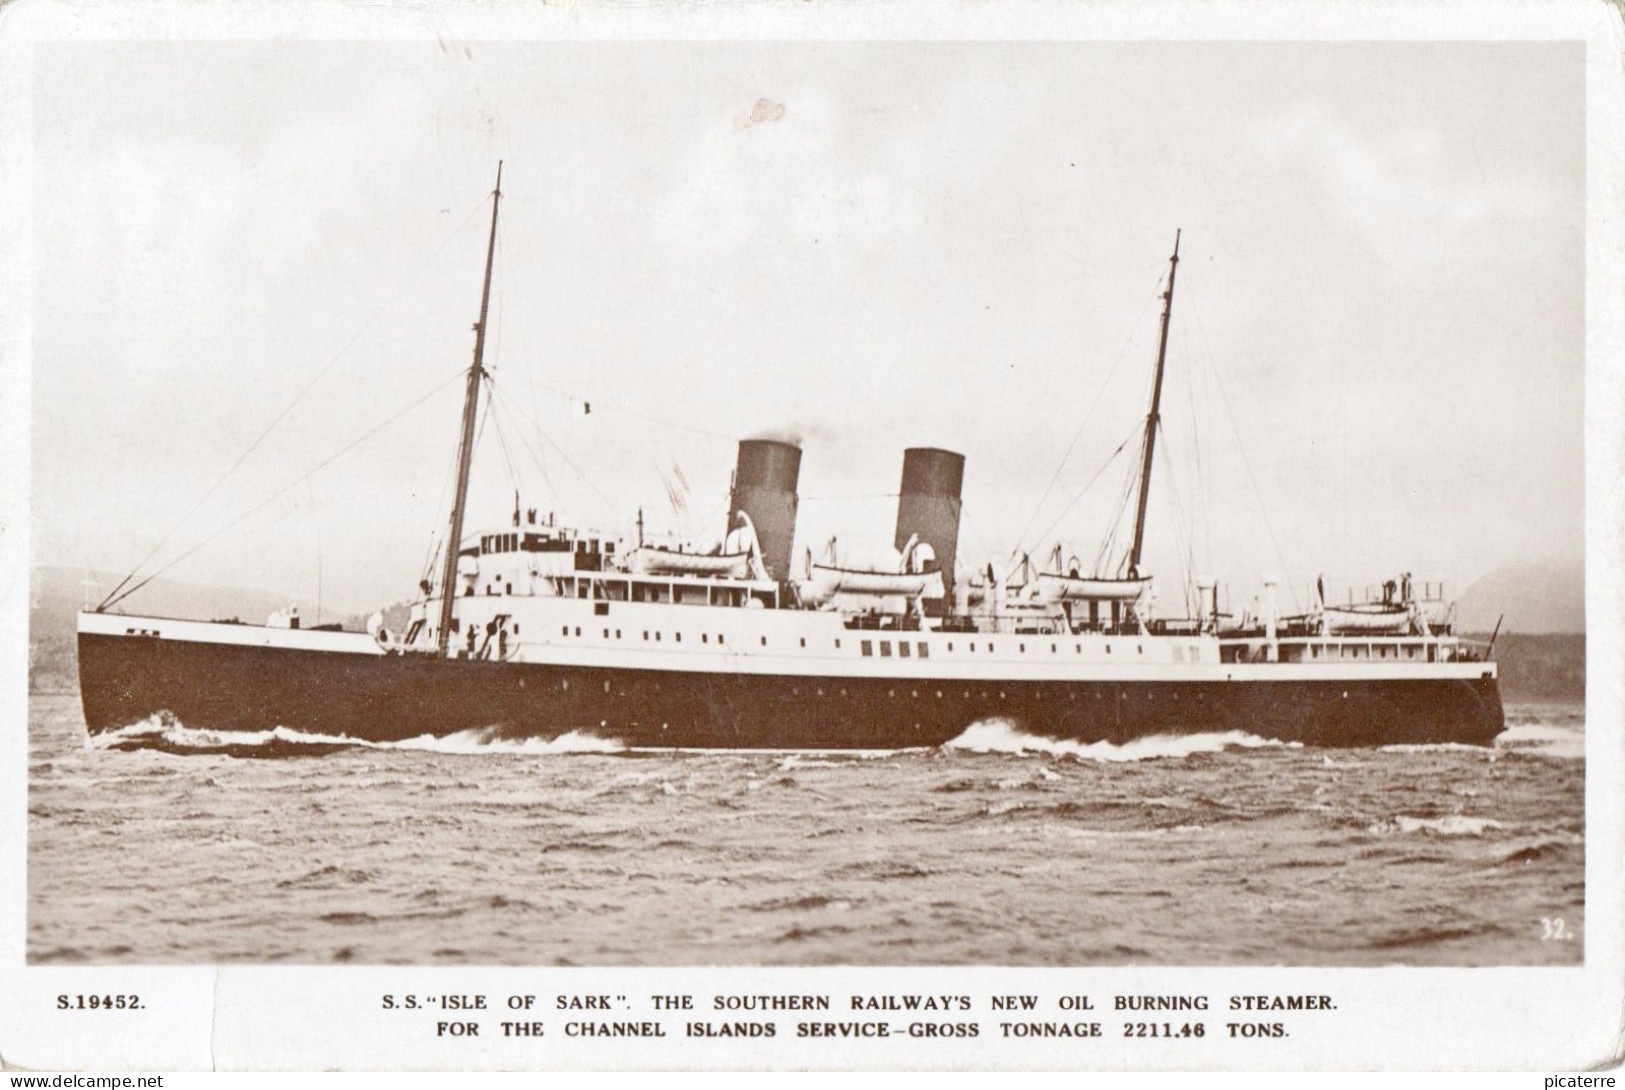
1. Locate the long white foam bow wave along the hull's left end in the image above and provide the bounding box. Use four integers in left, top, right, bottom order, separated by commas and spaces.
88, 715, 626, 755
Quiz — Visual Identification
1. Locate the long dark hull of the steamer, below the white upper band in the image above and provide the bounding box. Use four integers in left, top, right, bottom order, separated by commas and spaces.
78, 632, 1503, 749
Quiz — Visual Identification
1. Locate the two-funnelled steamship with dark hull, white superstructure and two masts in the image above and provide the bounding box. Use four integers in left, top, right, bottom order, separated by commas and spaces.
78, 169, 1503, 750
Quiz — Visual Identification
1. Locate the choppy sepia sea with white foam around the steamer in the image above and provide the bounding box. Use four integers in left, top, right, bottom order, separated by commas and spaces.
28, 695, 1584, 965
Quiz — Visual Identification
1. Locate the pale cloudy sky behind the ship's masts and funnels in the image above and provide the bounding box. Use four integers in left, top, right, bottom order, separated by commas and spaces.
33, 39, 1586, 609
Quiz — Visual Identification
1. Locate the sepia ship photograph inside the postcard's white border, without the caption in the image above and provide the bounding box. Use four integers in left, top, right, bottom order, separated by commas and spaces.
26, 36, 1588, 967
